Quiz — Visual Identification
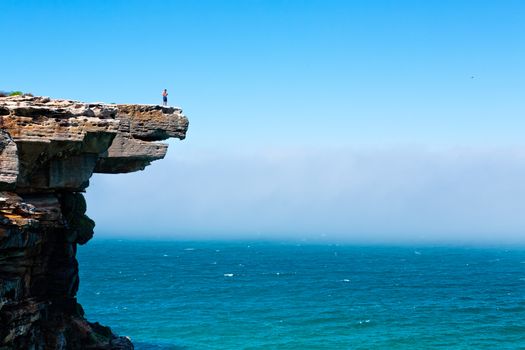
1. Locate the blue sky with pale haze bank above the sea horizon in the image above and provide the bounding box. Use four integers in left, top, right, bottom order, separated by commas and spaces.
0, 0, 525, 242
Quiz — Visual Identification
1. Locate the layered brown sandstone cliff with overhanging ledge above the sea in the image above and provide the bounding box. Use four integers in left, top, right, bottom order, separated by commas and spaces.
0, 96, 188, 350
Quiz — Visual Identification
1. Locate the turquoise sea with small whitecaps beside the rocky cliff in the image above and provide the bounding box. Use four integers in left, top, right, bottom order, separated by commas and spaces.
78, 239, 525, 350
